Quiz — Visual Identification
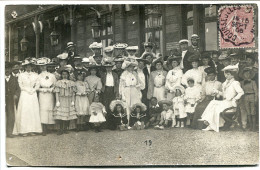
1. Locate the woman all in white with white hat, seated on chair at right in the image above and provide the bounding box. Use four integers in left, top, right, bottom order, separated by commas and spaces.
201, 65, 244, 132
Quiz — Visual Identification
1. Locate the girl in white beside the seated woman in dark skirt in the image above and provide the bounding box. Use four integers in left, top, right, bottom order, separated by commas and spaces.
184, 78, 202, 125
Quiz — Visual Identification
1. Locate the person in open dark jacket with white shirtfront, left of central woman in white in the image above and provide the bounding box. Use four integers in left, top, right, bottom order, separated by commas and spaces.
101, 62, 119, 129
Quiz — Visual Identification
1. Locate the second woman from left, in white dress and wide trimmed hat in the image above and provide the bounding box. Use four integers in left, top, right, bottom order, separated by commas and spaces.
36, 57, 56, 136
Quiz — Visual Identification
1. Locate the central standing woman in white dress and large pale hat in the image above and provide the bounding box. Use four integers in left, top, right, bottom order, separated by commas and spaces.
119, 58, 142, 122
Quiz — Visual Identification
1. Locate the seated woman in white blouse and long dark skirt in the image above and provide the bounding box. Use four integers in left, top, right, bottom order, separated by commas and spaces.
191, 67, 222, 129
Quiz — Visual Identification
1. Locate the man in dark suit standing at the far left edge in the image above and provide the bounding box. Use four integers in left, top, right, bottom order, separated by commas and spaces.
5, 62, 19, 137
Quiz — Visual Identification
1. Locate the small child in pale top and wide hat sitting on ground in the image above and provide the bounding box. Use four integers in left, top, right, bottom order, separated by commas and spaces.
154, 100, 176, 129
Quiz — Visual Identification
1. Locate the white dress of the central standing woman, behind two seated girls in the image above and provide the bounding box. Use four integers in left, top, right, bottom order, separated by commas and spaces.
119, 70, 142, 120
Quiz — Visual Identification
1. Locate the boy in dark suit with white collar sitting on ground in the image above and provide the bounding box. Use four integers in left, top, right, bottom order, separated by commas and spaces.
145, 97, 162, 128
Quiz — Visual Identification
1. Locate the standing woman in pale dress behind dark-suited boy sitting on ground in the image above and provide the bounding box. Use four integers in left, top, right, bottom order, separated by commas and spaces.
147, 58, 167, 101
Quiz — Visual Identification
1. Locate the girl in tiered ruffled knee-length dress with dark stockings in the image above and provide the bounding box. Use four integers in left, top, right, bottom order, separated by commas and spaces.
54, 68, 77, 135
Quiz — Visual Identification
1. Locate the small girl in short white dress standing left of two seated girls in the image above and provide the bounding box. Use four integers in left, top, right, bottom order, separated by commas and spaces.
89, 95, 107, 132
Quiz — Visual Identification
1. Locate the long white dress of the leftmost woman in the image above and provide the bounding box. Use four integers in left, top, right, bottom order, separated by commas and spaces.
13, 72, 42, 135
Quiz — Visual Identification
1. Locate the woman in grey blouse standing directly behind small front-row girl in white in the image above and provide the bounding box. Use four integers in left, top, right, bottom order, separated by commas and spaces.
84, 65, 102, 105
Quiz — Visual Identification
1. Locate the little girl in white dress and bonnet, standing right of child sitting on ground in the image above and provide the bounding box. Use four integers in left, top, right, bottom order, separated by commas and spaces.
172, 86, 187, 128
